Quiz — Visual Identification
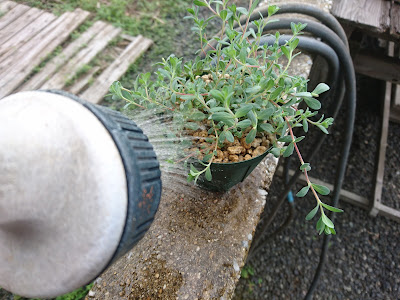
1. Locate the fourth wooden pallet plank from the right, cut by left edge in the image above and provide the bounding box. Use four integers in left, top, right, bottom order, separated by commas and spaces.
0, 12, 57, 60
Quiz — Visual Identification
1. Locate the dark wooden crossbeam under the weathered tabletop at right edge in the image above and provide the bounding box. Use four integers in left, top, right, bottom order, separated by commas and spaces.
353, 52, 400, 83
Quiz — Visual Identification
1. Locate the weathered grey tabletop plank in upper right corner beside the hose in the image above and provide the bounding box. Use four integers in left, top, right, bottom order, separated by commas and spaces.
331, 0, 391, 31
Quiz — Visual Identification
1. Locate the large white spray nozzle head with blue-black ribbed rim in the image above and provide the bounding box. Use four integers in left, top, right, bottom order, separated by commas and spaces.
0, 91, 161, 298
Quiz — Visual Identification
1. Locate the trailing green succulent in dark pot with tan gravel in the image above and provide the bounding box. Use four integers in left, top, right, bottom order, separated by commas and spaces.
110, 0, 342, 234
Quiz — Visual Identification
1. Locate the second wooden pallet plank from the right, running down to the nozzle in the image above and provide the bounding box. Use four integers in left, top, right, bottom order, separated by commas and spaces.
41, 25, 121, 89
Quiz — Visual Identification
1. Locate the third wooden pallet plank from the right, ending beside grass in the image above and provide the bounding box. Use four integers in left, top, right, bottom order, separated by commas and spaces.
0, 9, 89, 99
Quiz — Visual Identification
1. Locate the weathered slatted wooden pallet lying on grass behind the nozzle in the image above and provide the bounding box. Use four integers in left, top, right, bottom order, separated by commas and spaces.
0, 0, 152, 103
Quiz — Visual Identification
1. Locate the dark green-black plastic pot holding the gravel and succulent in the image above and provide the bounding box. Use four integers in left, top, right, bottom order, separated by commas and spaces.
194, 148, 271, 192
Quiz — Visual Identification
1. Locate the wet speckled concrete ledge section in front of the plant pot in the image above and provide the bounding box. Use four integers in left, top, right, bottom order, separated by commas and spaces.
87, 155, 277, 300
